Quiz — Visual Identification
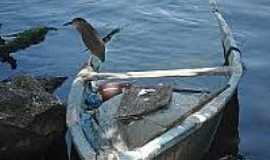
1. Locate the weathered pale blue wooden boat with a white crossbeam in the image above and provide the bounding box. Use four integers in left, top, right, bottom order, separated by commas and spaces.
67, 0, 243, 160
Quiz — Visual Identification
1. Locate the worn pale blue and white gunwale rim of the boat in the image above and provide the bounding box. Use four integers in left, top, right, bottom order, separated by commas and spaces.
67, 0, 243, 160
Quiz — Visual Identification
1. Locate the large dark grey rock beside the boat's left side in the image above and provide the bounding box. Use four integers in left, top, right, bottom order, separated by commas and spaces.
0, 75, 68, 160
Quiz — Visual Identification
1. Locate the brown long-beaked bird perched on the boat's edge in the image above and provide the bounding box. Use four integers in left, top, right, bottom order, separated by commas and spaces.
63, 17, 120, 62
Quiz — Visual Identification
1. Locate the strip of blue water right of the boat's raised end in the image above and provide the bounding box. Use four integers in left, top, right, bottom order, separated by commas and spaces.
222, 0, 270, 160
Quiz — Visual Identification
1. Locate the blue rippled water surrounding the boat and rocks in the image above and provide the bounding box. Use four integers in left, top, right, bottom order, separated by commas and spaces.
0, 0, 270, 160
